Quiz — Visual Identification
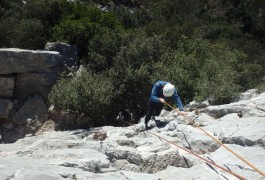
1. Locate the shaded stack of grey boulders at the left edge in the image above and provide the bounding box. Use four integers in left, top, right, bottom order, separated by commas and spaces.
0, 43, 78, 143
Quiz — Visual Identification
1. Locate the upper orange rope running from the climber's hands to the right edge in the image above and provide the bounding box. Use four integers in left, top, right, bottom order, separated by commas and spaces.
165, 102, 265, 177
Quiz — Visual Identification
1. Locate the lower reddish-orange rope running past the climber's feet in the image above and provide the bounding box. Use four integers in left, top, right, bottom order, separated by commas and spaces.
118, 116, 246, 180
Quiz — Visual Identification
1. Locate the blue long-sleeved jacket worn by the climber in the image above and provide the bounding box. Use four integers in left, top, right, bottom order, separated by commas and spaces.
149, 81, 183, 111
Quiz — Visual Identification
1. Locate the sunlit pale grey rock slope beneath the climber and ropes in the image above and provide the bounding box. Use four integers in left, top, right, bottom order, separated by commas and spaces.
0, 90, 265, 180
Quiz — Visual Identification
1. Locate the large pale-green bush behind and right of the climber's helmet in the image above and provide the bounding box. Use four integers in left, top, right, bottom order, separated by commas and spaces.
150, 36, 245, 104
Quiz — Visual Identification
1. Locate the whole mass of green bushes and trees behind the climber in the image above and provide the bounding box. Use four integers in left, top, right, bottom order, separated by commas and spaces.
0, 0, 265, 123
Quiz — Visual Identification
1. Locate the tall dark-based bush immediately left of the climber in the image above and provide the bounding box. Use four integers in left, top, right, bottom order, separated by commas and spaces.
105, 33, 167, 117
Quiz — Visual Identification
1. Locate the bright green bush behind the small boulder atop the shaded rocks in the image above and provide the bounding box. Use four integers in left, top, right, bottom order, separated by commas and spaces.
53, 5, 121, 58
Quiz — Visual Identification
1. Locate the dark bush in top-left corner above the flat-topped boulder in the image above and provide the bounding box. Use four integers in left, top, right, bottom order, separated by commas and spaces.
0, 0, 71, 49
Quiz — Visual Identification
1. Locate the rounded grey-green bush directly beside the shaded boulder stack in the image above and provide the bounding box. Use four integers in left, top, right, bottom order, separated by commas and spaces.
49, 69, 114, 125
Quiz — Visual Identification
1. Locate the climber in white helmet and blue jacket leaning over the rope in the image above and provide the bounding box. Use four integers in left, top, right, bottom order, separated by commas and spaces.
145, 81, 187, 129
